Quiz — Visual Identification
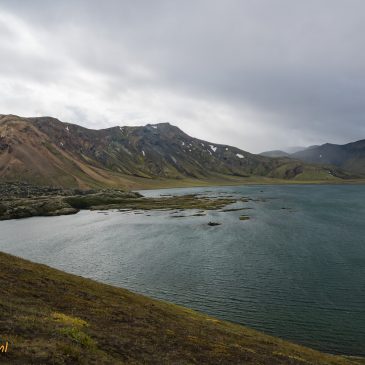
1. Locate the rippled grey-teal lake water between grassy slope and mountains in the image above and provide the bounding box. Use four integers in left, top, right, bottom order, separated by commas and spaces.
0, 185, 365, 355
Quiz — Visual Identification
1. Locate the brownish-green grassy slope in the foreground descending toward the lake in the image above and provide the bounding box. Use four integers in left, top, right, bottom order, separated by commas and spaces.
0, 253, 356, 365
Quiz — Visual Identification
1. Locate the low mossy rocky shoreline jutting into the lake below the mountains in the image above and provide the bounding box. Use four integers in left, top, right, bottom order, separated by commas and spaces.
0, 183, 236, 220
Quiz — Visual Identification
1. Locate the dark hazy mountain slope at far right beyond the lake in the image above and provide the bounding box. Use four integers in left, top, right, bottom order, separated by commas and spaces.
291, 139, 365, 176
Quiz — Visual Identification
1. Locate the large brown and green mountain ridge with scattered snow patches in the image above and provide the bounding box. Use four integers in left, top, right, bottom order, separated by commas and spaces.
0, 115, 349, 188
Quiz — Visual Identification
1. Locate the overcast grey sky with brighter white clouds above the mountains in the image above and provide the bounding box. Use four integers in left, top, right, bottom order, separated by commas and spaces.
0, 0, 365, 152
